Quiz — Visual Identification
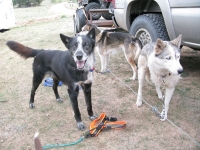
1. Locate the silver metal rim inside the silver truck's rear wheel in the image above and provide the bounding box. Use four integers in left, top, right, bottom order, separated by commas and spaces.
135, 28, 152, 46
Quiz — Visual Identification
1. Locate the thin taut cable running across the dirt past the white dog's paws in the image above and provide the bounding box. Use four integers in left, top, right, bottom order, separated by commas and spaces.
110, 71, 200, 147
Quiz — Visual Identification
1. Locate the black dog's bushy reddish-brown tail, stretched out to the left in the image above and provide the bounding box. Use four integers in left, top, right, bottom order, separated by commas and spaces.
6, 41, 41, 59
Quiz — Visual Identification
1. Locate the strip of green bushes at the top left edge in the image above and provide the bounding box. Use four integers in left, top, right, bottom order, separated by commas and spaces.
13, 0, 43, 7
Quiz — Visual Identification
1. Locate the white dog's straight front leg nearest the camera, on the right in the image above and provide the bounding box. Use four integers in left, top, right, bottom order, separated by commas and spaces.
160, 88, 174, 121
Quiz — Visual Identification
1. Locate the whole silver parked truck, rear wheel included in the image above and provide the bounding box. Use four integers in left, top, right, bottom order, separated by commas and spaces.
74, 0, 200, 49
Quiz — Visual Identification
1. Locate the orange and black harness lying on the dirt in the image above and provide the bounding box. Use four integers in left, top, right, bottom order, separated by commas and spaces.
85, 113, 126, 137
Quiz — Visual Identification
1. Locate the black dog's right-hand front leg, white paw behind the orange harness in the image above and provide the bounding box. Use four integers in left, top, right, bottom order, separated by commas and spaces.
80, 80, 97, 120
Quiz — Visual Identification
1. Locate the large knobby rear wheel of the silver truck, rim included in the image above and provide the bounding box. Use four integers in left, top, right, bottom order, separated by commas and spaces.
129, 14, 169, 46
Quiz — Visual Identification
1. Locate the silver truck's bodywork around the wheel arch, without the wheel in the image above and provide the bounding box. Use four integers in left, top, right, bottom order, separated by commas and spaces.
114, 0, 200, 49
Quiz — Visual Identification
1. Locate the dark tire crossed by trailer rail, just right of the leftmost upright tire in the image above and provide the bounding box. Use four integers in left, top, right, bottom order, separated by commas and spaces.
85, 2, 101, 20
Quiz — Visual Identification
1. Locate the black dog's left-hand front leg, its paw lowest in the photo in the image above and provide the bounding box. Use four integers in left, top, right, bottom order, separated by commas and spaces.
68, 86, 85, 130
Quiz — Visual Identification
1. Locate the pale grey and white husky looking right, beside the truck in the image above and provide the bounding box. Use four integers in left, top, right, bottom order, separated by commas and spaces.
136, 35, 183, 121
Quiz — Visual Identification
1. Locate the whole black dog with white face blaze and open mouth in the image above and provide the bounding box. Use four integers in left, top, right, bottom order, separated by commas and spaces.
6, 29, 96, 130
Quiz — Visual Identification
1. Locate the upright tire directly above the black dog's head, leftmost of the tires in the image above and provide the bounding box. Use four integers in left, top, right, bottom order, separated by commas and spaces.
74, 9, 86, 34
